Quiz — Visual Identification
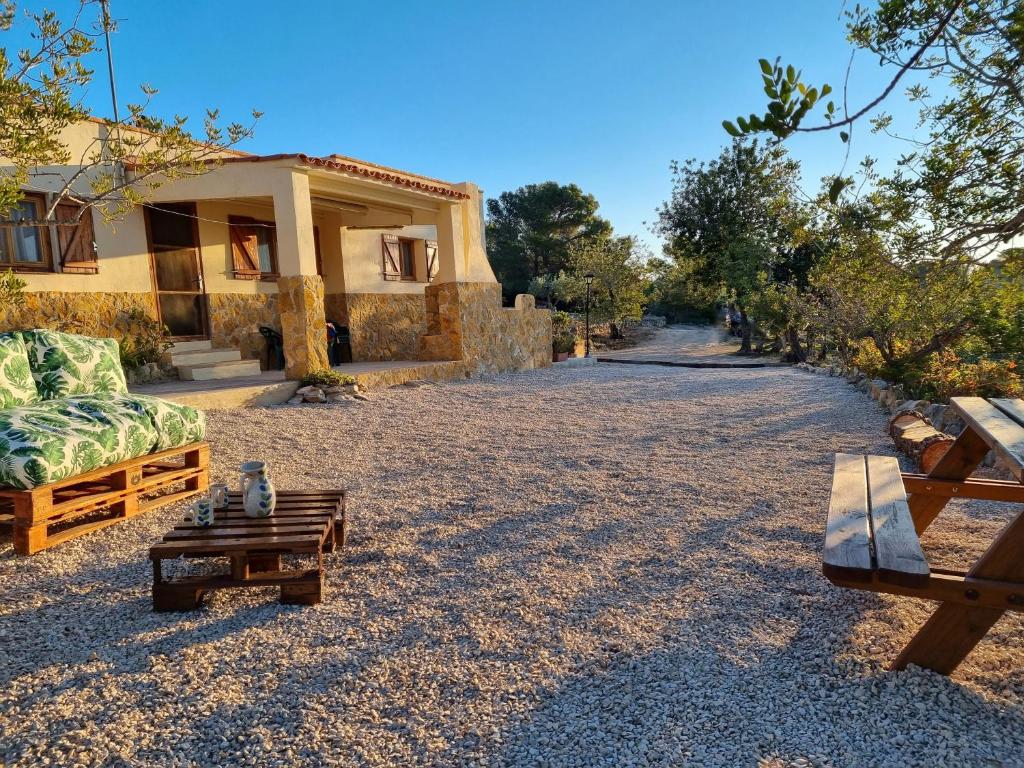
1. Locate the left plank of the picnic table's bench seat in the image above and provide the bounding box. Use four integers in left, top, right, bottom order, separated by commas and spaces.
822, 454, 872, 582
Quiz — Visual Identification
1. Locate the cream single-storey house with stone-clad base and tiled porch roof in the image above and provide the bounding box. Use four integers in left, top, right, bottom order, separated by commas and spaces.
0, 120, 551, 379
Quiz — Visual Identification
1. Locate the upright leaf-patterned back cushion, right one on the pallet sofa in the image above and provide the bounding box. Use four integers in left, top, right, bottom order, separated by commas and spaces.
22, 329, 128, 400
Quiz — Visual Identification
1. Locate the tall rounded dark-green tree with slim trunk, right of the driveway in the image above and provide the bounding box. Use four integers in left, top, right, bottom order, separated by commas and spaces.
657, 140, 808, 352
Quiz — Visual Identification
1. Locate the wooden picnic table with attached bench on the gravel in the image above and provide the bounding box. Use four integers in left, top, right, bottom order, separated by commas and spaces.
822, 397, 1024, 675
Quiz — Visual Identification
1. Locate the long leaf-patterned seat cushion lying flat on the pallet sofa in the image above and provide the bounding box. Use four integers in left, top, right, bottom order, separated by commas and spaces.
0, 392, 206, 489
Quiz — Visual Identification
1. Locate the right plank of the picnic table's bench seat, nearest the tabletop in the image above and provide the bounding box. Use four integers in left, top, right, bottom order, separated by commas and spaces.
867, 456, 931, 587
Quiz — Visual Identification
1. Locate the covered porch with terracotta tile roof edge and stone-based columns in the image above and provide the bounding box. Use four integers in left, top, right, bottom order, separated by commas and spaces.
145, 156, 485, 384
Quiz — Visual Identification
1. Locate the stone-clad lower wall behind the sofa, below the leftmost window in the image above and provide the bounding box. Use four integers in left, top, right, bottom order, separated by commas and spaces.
0, 291, 157, 338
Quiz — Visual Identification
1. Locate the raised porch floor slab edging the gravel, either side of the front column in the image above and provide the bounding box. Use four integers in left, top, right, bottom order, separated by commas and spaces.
129, 360, 466, 409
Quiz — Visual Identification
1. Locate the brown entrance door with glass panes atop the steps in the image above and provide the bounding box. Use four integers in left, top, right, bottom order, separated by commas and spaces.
145, 203, 209, 339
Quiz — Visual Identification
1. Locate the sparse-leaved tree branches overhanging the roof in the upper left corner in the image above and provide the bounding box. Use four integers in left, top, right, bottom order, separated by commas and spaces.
0, 0, 260, 225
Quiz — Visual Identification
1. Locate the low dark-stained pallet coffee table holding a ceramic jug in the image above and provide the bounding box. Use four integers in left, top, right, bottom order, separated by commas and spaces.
150, 490, 346, 611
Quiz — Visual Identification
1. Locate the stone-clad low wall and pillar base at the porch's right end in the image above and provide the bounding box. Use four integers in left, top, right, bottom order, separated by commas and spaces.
427, 283, 551, 373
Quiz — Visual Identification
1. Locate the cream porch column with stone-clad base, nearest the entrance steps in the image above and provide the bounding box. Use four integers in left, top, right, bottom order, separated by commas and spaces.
273, 169, 329, 379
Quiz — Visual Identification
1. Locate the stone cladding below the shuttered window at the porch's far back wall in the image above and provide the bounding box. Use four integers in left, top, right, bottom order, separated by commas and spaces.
345, 293, 427, 361
